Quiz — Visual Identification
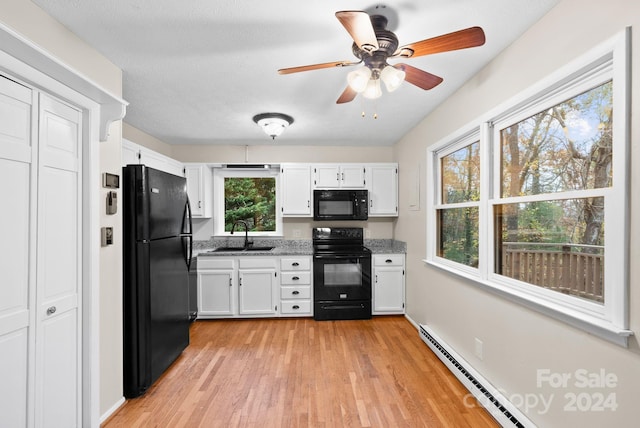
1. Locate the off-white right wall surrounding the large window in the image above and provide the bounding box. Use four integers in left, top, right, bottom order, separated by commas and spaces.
394, 0, 640, 427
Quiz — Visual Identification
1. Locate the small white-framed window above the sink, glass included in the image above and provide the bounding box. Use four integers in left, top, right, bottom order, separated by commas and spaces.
214, 168, 282, 236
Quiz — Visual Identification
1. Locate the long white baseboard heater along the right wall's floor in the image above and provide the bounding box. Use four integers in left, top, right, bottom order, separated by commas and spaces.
419, 324, 535, 428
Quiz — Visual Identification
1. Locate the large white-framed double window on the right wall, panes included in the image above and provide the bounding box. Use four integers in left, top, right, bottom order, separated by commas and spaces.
427, 29, 630, 344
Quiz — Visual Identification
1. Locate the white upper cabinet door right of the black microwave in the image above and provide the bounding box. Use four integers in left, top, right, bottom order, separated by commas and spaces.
367, 164, 398, 217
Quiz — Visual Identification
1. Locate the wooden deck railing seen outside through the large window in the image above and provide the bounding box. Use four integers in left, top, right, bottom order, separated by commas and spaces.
501, 242, 604, 302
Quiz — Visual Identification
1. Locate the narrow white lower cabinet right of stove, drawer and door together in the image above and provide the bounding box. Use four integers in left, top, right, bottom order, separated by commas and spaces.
372, 254, 405, 315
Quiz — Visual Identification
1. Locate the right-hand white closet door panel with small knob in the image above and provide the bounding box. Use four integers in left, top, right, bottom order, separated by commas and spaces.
35, 94, 82, 427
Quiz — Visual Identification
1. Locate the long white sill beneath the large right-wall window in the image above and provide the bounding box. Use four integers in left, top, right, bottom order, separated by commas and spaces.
423, 259, 634, 348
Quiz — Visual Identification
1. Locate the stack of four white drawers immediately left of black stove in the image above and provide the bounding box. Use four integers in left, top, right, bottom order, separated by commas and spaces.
280, 256, 313, 317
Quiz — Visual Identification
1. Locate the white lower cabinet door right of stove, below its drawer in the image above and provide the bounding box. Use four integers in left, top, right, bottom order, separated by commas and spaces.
373, 267, 404, 313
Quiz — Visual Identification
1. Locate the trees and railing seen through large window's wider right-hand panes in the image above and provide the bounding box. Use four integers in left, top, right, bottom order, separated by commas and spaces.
494, 81, 613, 302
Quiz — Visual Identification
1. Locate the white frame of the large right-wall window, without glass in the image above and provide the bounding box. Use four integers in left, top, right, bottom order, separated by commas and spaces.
424, 28, 633, 346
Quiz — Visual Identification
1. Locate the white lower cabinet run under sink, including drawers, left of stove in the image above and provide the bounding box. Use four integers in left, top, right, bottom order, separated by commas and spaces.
198, 256, 313, 319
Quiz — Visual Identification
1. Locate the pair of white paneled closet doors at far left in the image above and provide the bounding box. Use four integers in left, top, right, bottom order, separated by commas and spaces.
0, 76, 82, 428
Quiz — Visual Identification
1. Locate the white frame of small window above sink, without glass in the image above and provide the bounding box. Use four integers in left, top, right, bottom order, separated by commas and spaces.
213, 165, 283, 237
